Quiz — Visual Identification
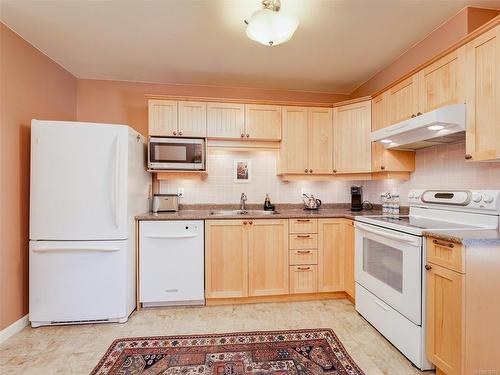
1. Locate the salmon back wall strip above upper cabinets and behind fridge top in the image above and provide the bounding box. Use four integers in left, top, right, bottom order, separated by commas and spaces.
77, 79, 348, 135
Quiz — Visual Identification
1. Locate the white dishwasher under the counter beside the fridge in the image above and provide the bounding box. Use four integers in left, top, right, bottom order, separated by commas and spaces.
139, 221, 205, 307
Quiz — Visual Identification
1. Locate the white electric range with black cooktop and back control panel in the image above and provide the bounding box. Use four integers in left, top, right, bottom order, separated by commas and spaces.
355, 189, 500, 370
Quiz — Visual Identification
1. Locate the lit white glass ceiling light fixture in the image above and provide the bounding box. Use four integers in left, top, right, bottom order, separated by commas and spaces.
245, 0, 299, 46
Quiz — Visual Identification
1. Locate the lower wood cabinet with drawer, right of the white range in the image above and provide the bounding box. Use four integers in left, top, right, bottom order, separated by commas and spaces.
425, 238, 500, 375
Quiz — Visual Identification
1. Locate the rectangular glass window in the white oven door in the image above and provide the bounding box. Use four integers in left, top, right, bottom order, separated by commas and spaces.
363, 238, 403, 293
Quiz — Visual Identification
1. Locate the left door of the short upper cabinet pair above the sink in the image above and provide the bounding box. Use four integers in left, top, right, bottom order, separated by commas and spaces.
207, 103, 245, 139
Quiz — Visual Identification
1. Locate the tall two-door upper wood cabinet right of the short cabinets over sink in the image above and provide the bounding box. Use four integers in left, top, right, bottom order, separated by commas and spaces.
280, 107, 333, 174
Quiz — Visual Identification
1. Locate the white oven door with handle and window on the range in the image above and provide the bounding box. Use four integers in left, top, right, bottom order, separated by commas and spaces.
355, 222, 422, 325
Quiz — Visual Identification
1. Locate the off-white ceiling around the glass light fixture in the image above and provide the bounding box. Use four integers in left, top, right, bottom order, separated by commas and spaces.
0, 0, 500, 93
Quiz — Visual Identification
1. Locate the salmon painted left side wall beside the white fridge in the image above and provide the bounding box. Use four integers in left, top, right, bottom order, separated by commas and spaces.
0, 23, 76, 330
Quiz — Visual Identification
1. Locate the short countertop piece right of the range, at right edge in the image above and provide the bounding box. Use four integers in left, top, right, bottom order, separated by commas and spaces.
423, 229, 500, 246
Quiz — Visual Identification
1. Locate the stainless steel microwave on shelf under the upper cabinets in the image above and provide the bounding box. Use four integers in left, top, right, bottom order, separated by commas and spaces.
148, 137, 205, 170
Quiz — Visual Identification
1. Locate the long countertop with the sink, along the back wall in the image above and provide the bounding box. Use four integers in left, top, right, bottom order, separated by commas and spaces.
135, 204, 382, 220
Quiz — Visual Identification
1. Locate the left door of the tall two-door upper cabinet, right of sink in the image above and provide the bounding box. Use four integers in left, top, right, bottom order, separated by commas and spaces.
280, 107, 309, 174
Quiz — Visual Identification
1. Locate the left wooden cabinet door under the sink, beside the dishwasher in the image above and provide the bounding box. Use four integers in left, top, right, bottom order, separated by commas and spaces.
205, 220, 248, 298
